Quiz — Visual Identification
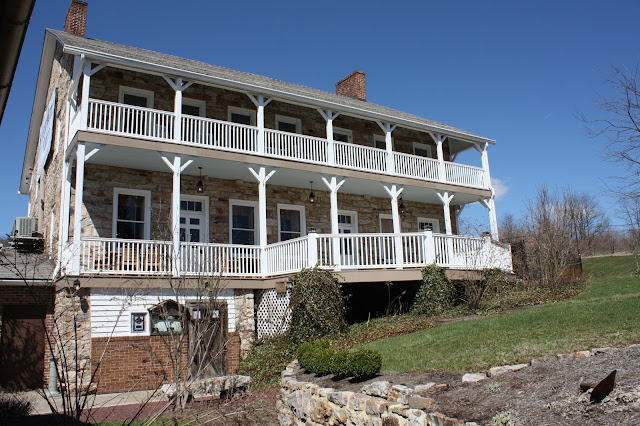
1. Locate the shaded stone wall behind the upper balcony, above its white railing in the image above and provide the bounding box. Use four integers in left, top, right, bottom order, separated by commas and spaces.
90, 68, 449, 160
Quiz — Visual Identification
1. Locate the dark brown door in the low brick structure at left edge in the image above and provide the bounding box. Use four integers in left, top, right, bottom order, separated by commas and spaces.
0, 305, 45, 390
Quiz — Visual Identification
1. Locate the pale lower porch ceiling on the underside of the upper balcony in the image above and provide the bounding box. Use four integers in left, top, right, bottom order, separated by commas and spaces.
86, 143, 486, 205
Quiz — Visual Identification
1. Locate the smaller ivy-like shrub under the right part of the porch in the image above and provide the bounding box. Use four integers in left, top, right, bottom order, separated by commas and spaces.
411, 264, 455, 315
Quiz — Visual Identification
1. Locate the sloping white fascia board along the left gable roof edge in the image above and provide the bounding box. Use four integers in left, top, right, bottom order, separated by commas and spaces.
18, 31, 56, 195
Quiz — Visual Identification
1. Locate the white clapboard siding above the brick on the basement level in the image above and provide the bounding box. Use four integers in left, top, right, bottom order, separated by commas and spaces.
91, 289, 236, 337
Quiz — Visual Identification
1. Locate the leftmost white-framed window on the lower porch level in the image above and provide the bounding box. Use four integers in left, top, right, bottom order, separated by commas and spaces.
113, 188, 151, 240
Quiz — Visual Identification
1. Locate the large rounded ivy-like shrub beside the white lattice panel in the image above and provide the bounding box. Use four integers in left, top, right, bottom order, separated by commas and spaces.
289, 266, 347, 342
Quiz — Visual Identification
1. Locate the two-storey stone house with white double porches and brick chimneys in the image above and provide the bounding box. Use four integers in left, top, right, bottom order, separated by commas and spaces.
13, 0, 511, 390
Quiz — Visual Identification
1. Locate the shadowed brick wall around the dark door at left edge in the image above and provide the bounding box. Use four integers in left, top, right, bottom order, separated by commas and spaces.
0, 285, 55, 386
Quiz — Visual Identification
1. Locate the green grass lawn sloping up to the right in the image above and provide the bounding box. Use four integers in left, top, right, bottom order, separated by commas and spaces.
364, 256, 640, 372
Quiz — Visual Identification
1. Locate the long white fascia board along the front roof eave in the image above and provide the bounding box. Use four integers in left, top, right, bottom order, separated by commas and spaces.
64, 46, 496, 144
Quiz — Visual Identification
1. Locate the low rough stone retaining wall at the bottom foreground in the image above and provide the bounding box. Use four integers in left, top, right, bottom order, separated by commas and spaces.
277, 361, 475, 426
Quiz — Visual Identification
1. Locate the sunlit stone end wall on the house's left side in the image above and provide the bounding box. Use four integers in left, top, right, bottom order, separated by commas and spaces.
29, 45, 74, 258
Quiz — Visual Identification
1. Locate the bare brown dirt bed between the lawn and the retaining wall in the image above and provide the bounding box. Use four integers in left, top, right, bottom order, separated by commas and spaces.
297, 346, 640, 425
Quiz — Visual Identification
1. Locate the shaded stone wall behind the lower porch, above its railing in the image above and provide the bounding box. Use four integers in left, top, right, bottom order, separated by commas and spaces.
82, 163, 457, 244
